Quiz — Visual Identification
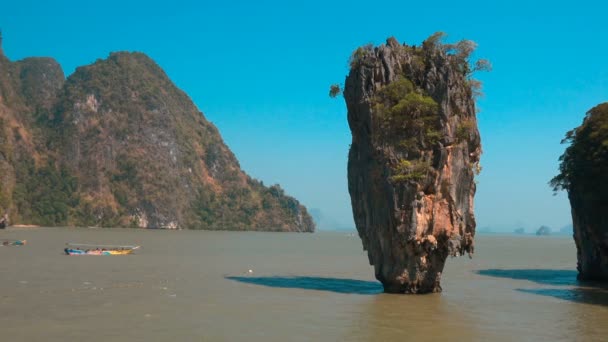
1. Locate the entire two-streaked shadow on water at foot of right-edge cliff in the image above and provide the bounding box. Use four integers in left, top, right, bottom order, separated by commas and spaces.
477, 269, 608, 306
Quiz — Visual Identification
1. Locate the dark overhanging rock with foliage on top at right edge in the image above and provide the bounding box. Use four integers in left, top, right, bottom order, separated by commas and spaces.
551, 103, 608, 281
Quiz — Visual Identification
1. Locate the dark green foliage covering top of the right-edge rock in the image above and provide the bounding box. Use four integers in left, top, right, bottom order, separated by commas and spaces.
550, 103, 608, 203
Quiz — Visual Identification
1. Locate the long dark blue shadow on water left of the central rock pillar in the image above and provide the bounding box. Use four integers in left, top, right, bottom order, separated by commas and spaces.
225, 276, 383, 295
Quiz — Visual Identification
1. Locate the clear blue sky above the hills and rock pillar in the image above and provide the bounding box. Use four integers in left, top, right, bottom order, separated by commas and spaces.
0, 0, 608, 230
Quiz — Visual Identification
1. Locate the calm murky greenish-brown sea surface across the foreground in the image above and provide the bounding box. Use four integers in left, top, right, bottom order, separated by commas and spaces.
0, 228, 608, 342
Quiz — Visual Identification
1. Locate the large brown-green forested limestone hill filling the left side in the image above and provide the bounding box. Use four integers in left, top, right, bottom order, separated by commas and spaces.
0, 37, 315, 232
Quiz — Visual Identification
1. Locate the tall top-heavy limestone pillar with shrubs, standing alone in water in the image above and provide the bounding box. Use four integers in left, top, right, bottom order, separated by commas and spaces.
344, 37, 481, 293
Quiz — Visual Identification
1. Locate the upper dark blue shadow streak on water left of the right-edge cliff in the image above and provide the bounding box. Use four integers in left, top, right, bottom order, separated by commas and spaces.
476, 268, 579, 286
